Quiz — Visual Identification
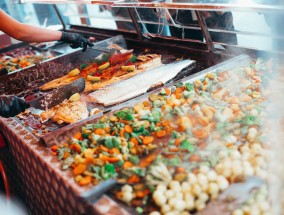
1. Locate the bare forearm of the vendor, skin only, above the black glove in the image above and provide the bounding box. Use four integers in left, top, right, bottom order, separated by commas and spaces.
0, 9, 62, 42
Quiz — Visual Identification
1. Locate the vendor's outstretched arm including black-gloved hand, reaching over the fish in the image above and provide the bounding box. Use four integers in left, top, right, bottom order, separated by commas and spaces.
0, 9, 95, 52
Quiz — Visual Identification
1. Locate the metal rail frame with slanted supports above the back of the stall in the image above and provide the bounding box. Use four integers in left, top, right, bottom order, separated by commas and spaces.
27, 0, 284, 54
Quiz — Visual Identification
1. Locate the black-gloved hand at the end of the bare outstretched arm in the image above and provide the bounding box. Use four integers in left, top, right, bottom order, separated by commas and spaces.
60, 32, 95, 52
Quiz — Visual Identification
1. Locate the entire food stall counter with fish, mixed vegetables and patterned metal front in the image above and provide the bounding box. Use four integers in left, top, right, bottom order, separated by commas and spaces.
0, 0, 283, 215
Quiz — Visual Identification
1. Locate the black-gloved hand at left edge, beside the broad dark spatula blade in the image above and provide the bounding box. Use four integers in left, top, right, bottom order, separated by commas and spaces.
0, 96, 26, 117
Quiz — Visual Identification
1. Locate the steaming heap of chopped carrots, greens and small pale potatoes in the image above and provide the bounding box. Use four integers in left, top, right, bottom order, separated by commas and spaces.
48, 54, 271, 214
